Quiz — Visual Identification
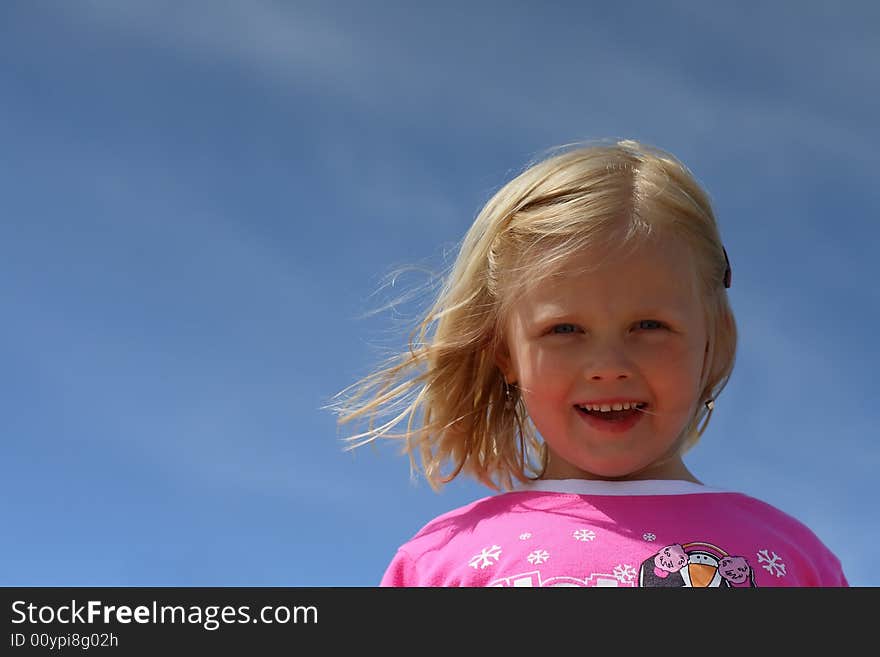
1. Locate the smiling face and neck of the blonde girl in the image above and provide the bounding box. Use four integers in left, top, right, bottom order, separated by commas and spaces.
497, 237, 708, 479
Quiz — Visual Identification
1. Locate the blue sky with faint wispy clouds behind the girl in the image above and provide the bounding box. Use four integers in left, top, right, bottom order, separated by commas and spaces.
0, 0, 880, 586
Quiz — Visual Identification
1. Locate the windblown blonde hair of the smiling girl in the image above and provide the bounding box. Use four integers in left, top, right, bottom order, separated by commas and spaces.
330, 140, 737, 490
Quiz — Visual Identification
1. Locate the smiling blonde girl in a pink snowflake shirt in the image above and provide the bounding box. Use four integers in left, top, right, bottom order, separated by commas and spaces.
335, 141, 848, 587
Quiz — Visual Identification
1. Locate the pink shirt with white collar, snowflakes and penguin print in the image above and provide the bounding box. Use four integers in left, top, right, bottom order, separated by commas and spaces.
380, 479, 848, 587
